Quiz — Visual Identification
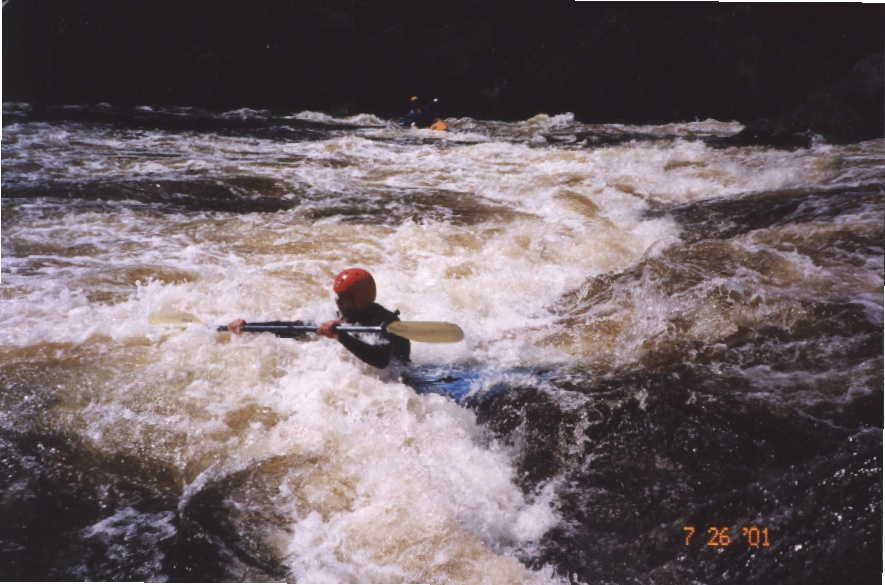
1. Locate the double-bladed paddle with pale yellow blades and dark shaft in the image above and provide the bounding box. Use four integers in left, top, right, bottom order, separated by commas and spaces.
148, 311, 464, 343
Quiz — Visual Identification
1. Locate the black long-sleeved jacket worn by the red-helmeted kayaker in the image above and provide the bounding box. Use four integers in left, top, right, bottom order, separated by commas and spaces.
268, 303, 412, 368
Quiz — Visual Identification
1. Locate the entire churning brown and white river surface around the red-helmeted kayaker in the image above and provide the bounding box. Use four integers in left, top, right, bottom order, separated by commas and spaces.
0, 103, 885, 585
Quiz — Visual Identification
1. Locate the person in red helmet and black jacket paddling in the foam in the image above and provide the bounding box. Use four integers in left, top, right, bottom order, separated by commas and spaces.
227, 268, 411, 368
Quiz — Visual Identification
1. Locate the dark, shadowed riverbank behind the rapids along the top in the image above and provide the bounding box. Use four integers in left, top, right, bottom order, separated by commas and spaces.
3, 0, 885, 146
